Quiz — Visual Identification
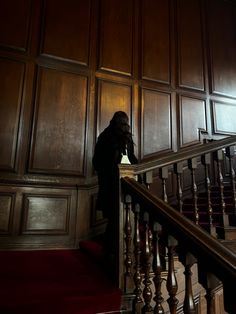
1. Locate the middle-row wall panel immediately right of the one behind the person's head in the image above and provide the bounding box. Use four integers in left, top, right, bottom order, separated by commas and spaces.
142, 89, 172, 157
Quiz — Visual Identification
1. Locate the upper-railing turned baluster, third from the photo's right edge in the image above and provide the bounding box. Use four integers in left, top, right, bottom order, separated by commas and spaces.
201, 154, 216, 237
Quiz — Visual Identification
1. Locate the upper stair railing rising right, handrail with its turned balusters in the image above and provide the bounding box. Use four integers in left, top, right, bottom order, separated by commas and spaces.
120, 136, 236, 238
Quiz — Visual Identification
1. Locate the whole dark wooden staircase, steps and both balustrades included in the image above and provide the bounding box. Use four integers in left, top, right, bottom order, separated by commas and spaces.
119, 137, 236, 314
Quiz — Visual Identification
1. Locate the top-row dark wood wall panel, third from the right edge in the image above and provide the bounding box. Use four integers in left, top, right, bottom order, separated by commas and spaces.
141, 0, 170, 84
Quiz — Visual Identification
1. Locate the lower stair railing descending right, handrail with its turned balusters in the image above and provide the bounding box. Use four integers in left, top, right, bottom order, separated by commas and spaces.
120, 177, 236, 313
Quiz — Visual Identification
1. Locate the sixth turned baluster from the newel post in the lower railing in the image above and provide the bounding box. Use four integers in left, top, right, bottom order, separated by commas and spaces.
183, 253, 197, 314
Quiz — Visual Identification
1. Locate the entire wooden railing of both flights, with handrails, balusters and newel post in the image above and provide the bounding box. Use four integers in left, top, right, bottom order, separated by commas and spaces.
118, 137, 236, 314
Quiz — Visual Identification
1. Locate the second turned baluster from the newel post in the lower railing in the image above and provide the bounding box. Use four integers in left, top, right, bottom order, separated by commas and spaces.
134, 204, 143, 312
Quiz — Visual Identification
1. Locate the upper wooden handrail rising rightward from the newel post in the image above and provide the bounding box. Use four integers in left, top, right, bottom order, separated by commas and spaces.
119, 136, 236, 175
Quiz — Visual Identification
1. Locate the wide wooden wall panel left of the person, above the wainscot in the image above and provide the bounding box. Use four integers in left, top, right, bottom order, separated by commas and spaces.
30, 68, 87, 175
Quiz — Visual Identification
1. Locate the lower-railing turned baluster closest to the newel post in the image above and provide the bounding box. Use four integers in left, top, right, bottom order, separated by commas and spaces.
124, 195, 132, 290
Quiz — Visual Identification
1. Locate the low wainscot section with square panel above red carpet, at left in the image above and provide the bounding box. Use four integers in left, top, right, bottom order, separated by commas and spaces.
0, 185, 77, 249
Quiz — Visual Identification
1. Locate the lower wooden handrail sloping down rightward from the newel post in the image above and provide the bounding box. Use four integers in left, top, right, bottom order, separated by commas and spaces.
121, 177, 236, 288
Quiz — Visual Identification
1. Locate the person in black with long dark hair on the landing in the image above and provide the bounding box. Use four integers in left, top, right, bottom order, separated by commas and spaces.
93, 111, 138, 254
